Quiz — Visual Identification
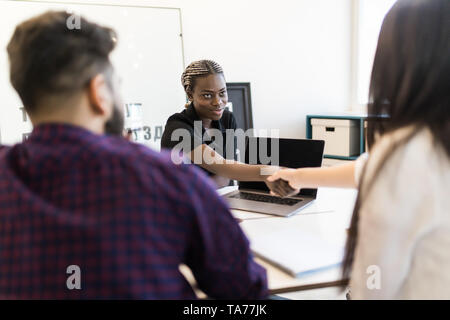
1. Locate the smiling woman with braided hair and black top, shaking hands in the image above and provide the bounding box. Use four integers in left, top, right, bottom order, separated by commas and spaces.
161, 60, 293, 196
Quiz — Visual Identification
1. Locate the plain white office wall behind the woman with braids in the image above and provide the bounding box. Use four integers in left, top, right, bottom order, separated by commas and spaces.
1, 0, 351, 138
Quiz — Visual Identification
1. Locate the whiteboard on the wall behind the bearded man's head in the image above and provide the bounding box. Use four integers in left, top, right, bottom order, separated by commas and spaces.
0, 0, 186, 150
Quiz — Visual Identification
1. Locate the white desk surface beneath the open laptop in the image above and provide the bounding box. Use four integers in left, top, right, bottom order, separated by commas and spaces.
183, 187, 357, 293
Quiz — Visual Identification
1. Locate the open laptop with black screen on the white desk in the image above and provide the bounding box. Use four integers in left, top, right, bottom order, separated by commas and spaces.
224, 137, 325, 217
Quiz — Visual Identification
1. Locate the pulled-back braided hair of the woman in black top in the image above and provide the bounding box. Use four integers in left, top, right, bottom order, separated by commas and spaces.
181, 60, 223, 108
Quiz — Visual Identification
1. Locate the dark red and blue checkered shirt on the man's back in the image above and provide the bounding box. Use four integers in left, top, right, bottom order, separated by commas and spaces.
0, 124, 267, 299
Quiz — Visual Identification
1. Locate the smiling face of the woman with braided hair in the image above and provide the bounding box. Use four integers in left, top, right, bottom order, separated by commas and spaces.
189, 74, 228, 120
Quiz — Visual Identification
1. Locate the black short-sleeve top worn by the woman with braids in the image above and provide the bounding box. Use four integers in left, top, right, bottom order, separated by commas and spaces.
161, 103, 237, 175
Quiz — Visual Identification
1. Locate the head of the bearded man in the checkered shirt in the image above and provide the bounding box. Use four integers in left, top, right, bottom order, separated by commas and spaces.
7, 12, 123, 134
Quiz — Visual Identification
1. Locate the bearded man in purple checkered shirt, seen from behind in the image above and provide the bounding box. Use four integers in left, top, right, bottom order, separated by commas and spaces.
0, 12, 267, 299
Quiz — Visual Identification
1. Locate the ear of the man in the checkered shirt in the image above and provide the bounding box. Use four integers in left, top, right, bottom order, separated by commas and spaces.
88, 74, 113, 117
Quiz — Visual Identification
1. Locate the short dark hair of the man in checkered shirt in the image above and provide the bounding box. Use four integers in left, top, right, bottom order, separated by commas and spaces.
7, 11, 117, 113
